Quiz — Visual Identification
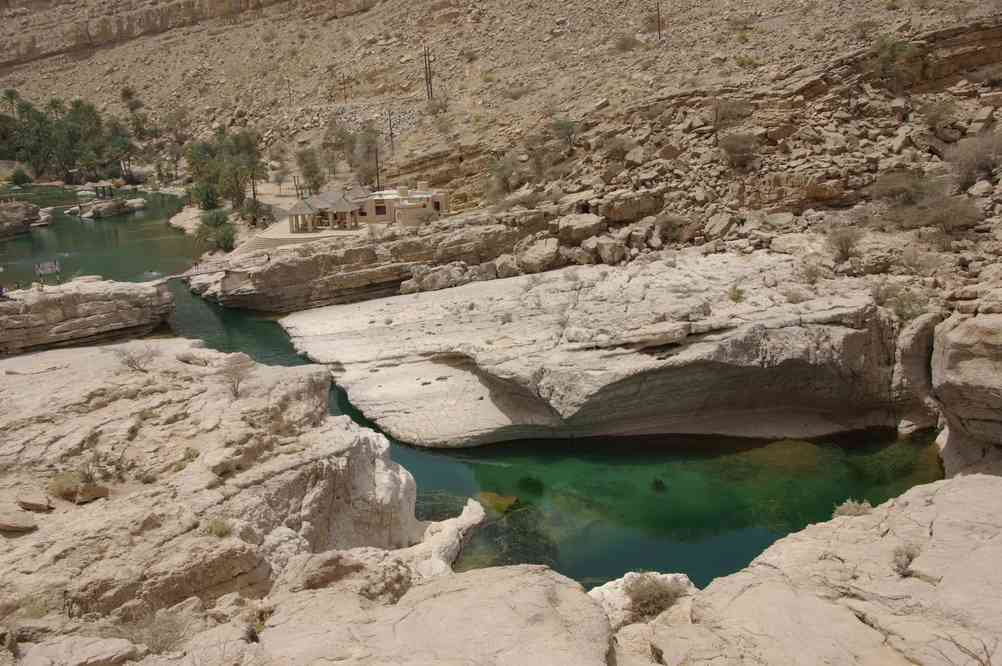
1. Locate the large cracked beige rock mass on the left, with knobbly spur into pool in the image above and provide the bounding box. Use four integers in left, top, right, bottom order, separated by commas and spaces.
0, 340, 484, 648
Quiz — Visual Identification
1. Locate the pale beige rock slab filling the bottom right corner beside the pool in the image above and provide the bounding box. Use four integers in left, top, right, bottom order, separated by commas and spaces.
615, 475, 1002, 666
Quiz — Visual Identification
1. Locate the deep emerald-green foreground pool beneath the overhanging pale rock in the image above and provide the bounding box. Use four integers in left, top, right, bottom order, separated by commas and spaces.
397, 433, 942, 586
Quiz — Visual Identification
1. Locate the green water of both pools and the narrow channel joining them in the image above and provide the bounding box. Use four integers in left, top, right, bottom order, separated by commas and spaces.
0, 188, 942, 586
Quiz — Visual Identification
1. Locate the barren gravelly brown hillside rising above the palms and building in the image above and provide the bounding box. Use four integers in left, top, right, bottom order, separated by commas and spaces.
0, 0, 999, 195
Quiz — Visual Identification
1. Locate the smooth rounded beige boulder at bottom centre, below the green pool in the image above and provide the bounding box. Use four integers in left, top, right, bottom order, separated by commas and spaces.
158, 566, 611, 666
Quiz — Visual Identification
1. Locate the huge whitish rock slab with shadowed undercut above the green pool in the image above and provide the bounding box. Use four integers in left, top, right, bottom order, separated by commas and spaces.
282, 251, 898, 447
